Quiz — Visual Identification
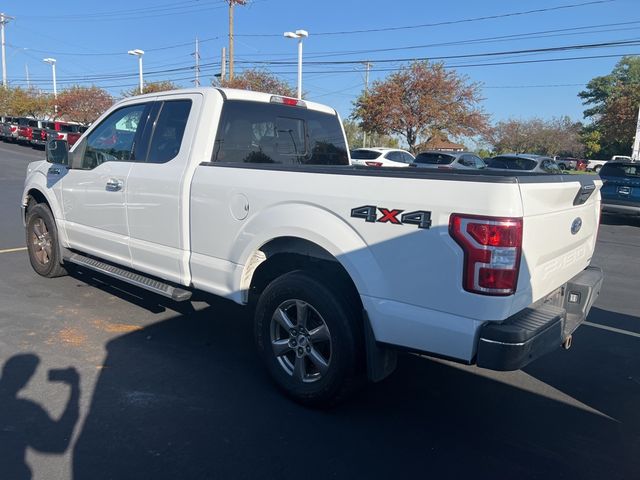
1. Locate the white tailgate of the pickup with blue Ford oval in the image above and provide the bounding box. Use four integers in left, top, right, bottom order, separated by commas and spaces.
518, 175, 602, 302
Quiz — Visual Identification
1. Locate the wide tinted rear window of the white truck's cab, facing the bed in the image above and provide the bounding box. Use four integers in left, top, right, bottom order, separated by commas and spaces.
213, 100, 349, 165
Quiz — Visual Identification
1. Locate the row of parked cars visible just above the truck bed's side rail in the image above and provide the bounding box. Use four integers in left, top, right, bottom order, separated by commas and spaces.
351, 148, 568, 173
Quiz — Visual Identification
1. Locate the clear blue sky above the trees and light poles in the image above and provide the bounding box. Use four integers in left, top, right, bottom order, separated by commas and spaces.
3, 0, 640, 121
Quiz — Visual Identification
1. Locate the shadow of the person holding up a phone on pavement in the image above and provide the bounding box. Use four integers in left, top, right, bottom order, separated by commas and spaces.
0, 354, 80, 480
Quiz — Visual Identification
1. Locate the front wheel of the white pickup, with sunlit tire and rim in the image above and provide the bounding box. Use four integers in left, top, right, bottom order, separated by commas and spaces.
26, 203, 67, 278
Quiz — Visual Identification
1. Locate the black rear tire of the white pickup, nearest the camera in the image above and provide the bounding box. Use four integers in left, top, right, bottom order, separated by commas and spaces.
255, 271, 364, 407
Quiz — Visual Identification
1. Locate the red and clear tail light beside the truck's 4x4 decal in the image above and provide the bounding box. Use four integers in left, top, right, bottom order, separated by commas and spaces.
449, 213, 522, 296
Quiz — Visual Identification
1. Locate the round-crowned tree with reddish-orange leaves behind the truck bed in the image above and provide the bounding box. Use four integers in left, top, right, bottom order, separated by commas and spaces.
353, 61, 489, 152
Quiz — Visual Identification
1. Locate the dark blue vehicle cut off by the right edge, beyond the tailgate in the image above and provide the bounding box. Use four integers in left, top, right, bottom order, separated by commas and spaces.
600, 161, 640, 215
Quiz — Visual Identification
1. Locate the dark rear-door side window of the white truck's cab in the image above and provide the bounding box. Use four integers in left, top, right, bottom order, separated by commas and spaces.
147, 100, 191, 163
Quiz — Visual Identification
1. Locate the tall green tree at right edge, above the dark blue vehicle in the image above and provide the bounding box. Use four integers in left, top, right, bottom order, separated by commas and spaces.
578, 56, 640, 157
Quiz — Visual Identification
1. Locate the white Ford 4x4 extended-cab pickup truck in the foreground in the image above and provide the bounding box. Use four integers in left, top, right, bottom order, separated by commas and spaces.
22, 88, 603, 405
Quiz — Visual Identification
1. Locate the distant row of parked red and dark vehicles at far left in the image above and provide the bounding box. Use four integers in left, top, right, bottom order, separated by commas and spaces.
0, 117, 87, 148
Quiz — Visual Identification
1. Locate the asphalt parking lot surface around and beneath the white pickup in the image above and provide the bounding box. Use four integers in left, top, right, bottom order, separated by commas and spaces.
0, 143, 640, 480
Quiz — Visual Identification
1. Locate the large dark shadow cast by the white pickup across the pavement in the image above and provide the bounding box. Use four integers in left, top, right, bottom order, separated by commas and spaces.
74, 292, 640, 480
